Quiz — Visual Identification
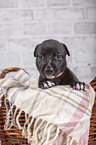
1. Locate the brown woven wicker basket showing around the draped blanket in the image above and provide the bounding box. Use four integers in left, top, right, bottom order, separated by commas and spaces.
0, 68, 96, 145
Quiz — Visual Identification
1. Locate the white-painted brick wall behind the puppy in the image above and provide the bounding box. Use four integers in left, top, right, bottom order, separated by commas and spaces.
0, 0, 96, 81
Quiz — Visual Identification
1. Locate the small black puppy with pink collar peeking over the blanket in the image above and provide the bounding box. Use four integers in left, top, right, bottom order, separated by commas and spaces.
34, 39, 85, 89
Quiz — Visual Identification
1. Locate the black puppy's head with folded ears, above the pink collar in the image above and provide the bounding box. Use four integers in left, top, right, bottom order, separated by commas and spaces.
34, 39, 70, 79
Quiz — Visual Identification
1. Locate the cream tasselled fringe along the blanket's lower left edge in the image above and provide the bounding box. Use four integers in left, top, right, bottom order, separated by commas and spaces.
0, 91, 79, 145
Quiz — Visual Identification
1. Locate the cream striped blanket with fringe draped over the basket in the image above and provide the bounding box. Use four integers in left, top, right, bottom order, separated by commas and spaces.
0, 70, 95, 145
